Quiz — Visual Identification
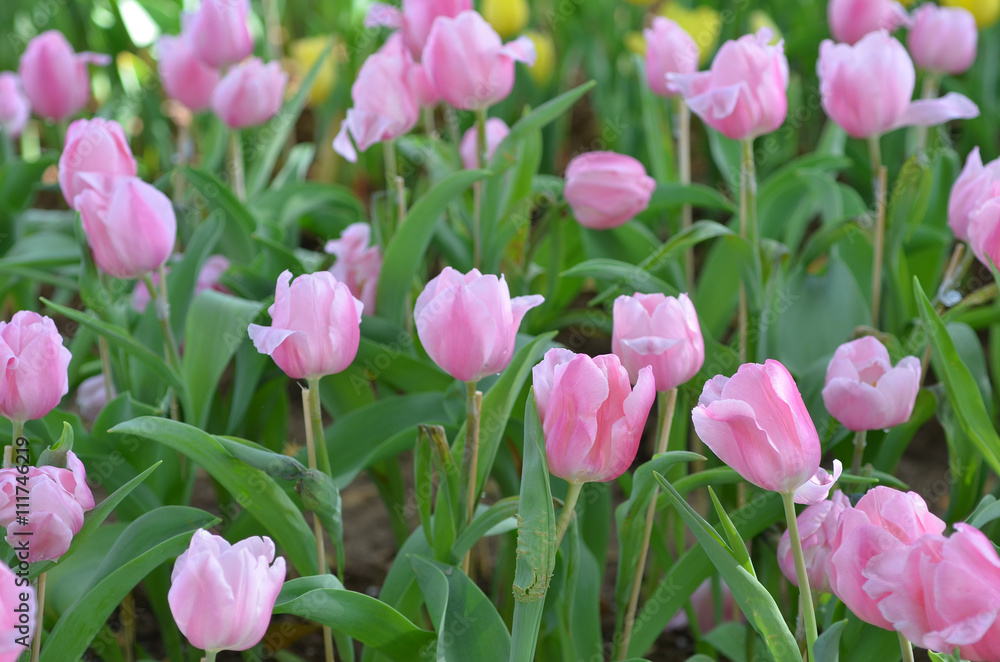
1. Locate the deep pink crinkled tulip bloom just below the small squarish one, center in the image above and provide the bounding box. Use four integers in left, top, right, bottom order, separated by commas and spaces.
532, 348, 656, 483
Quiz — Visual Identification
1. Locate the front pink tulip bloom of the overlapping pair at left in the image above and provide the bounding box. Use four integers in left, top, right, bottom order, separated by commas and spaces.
77, 177, 177, 278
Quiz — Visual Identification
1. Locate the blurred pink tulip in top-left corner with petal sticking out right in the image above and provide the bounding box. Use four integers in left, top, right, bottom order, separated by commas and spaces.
18, 30, 111, 122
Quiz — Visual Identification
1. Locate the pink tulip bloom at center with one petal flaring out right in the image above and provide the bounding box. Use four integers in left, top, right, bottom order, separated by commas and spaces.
413, 267, 544, 382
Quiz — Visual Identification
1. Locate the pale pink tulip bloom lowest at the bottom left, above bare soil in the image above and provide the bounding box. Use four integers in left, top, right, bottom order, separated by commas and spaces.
167, 529, 285, 651
